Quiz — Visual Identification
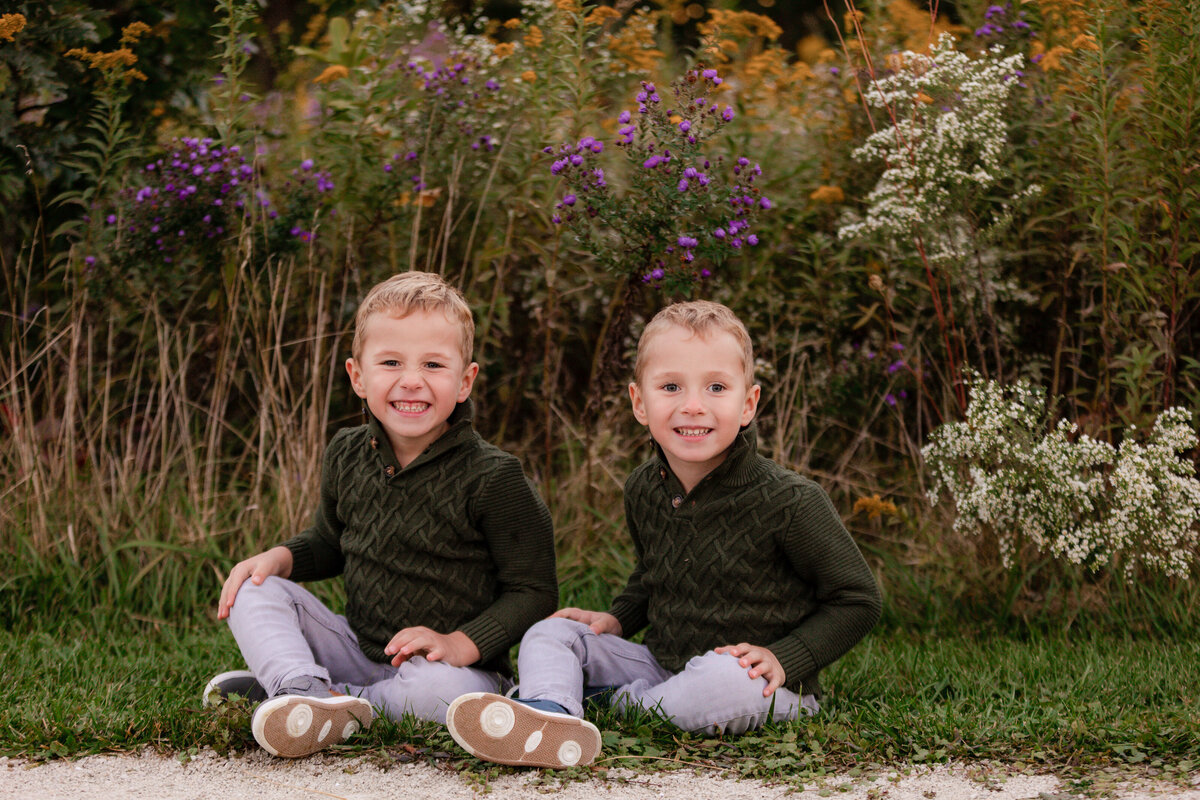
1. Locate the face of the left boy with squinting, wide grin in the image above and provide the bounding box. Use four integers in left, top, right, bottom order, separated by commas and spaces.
346, 309, 479, 467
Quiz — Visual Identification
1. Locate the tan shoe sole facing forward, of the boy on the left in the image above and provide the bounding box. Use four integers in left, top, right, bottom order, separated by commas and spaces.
250, 694, 372, 758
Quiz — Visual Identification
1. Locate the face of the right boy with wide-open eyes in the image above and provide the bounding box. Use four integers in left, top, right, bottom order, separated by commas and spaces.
629, 326, 760, 492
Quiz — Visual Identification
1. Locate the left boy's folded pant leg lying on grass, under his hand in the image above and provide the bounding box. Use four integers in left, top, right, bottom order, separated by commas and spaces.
348, 656, 502, 724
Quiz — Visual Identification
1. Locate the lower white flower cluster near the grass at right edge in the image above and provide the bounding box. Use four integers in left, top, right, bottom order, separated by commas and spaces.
922, 379, 1200, 578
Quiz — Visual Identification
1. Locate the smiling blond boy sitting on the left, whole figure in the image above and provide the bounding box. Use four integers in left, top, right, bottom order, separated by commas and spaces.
204, 272, 558, 757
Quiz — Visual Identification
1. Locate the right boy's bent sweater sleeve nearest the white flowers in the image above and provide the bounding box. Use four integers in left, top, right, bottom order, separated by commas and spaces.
767, 482, 882, 685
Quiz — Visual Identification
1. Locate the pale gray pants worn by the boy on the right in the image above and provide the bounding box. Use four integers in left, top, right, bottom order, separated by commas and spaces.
517, 618, 820, 736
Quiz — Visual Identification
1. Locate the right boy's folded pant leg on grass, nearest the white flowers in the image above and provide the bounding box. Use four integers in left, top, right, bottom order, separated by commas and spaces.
613, 652, 818, 736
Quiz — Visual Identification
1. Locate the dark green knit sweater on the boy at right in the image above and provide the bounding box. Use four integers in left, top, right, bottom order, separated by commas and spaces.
610, 427, 881, 697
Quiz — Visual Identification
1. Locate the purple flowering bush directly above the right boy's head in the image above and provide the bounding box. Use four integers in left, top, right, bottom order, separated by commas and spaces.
544, 67, 770, 293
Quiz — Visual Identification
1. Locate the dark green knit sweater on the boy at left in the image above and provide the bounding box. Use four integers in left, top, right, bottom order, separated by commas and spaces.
284, 399, 558, 670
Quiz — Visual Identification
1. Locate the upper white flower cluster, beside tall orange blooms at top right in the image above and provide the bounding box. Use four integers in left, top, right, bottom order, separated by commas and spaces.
838, 34, 1024, 263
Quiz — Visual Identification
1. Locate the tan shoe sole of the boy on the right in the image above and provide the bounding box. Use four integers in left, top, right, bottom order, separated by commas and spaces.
446, 692, 600, 769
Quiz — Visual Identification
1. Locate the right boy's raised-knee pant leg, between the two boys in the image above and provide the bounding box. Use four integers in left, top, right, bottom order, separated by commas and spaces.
517, 616, 671, 717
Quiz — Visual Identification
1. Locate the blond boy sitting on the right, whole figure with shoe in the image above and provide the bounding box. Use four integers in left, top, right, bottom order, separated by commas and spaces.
446, 301, 881, 768
